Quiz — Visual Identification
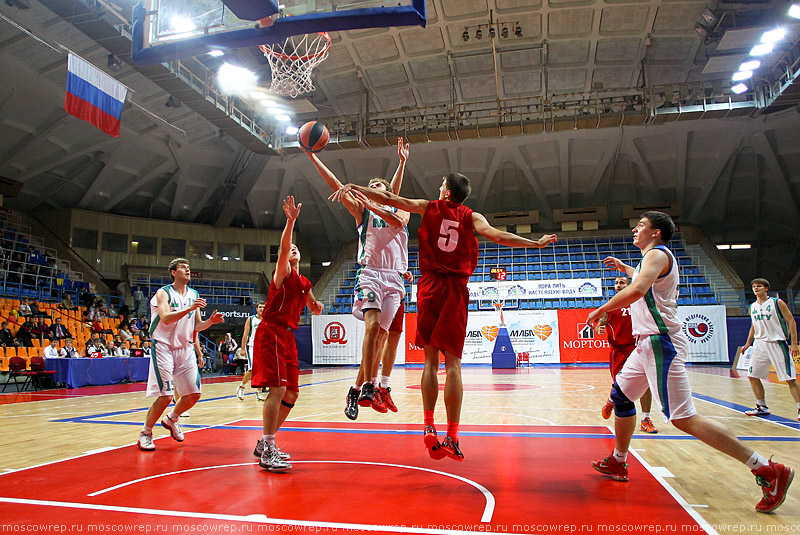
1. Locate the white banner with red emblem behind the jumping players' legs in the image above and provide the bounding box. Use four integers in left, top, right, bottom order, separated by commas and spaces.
311, 314, 406, 364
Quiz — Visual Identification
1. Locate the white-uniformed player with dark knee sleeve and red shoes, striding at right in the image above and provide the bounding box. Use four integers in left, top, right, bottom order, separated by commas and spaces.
586, 211, 794, 513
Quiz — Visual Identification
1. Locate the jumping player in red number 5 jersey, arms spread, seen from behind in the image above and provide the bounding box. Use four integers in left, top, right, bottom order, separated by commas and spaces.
331, 173, 556, 461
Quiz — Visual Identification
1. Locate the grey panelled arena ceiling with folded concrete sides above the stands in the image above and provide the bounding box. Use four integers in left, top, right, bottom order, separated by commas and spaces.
0, 0, 800, 279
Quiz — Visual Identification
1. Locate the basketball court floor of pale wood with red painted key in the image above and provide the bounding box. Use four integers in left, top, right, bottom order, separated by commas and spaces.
0, 366, 800, 534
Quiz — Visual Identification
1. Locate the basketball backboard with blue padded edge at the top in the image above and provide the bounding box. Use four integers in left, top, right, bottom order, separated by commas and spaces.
131, 0, 427, 65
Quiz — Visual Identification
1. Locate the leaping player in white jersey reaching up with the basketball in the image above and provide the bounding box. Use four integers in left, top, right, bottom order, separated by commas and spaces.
307, 138, 409, 420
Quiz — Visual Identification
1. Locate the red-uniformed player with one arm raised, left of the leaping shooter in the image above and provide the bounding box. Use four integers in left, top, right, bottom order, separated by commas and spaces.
251, 196, 323, 472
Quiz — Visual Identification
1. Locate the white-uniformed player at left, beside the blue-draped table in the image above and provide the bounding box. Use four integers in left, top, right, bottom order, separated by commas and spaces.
138, 258, 223, 451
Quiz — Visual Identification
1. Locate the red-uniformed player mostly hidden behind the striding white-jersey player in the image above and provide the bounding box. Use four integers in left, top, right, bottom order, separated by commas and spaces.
597, 275, 658, 433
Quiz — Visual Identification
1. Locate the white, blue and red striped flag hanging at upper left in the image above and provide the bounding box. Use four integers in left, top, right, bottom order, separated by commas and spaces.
64, 54, 128, 137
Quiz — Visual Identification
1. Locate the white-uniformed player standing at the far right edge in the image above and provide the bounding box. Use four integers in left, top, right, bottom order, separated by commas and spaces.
742, 279, 800, 420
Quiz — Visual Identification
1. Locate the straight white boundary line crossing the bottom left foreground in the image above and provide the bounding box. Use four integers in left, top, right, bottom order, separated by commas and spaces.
0, 497, 506, 535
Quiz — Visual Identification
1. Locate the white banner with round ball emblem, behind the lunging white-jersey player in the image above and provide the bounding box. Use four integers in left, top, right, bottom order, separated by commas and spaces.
678, 305, 730, 362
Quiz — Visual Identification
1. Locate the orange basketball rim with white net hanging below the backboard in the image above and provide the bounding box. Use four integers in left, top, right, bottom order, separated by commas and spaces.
258, 32, 331, 98
